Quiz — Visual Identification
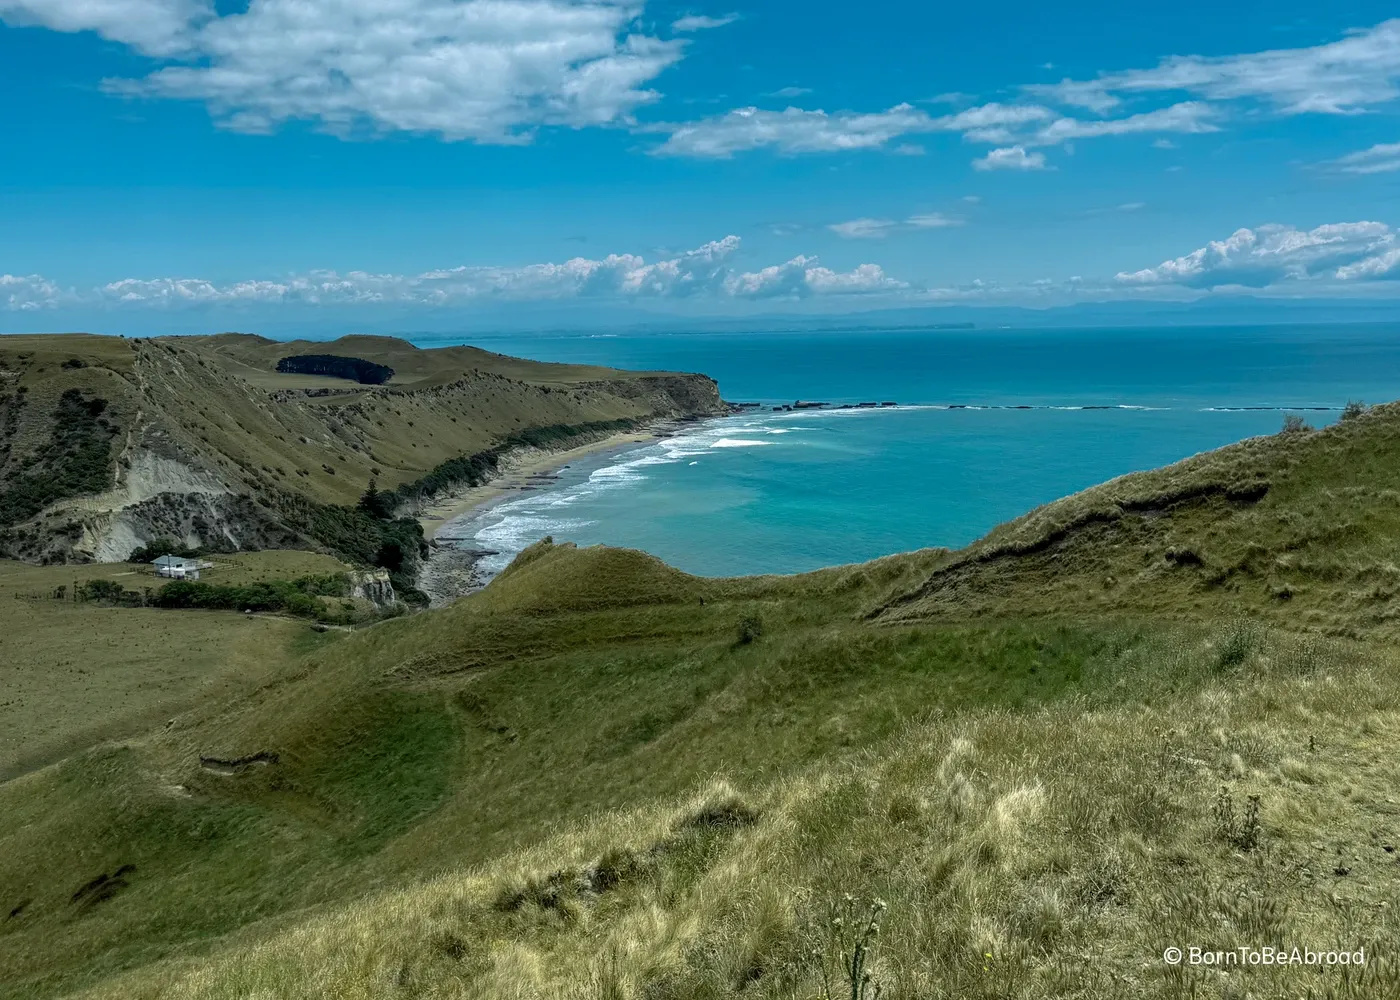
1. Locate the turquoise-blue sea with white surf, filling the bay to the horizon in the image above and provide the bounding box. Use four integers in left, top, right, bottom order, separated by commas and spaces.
416, 325, 1400, 576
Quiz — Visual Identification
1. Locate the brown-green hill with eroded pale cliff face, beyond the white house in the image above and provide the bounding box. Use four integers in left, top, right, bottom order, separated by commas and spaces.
0, 333, 724, 562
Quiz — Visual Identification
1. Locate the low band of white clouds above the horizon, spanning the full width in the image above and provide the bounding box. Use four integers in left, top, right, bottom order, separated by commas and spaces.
16, 222, 1400, 312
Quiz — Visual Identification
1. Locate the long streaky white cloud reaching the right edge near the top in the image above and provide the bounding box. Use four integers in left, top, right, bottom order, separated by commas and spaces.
1025, 20, 1400, 115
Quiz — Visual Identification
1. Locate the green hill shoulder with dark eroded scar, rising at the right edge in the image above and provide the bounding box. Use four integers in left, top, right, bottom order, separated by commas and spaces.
879, 403, 1400, 636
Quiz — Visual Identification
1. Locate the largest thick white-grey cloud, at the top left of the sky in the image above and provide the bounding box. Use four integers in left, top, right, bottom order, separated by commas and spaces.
66, 0, 685, 143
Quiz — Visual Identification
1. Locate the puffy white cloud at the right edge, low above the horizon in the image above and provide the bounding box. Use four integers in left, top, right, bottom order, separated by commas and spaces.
1117, 221, 1400, 289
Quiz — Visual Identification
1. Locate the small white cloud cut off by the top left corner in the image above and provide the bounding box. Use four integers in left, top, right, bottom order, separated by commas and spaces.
0, 0, 214, 56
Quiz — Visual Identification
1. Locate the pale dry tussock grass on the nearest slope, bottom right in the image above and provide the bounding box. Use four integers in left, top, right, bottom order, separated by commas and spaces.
54, 621, 1400, 1000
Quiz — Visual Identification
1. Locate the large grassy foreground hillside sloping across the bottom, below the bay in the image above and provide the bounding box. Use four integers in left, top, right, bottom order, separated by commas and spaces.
8, 400, 1400, 1000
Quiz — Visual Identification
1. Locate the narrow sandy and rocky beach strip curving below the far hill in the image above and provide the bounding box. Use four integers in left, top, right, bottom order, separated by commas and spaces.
417, 417, 711, 608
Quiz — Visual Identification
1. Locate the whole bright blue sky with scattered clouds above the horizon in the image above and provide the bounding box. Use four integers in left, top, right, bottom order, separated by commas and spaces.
0, 0, 1400, 332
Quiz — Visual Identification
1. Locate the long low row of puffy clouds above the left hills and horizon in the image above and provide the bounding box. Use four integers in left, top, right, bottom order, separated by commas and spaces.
8, 235, 907, 311
